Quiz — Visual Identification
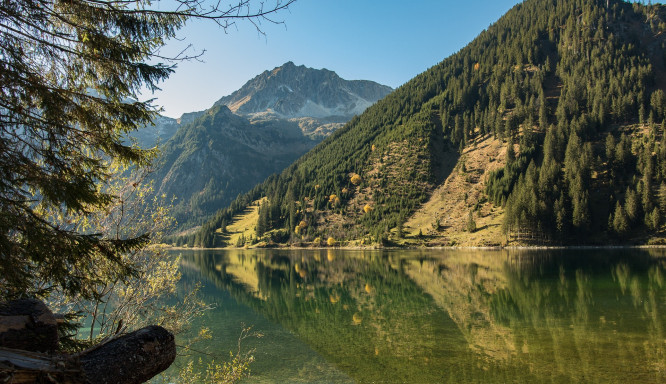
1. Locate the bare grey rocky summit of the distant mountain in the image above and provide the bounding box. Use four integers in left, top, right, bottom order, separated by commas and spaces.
216, 62, 392, 120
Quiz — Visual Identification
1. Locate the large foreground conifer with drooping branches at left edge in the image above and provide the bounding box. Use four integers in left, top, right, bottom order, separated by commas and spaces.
0, 0, 293, 299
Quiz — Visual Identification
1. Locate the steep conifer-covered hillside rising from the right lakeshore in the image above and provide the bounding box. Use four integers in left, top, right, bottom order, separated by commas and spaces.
185, 0, 666, 245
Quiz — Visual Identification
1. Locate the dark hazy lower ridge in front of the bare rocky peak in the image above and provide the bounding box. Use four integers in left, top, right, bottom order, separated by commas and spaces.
151, 106, 316, 228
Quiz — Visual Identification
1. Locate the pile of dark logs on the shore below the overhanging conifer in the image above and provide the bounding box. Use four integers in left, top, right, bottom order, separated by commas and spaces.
0, 300, 176, 384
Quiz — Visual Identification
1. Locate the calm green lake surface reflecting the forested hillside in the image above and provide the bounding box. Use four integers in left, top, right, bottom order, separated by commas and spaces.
172, 249, 666, 383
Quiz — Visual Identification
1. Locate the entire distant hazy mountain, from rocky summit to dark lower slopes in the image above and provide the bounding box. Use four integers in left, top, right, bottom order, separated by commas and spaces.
148, 63, 391, 229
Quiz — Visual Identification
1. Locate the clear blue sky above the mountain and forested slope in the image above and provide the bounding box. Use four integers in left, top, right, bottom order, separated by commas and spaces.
145, 0, 520, 117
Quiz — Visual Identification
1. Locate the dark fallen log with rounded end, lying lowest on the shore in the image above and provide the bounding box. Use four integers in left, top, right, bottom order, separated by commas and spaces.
0, 325, 176, 384
